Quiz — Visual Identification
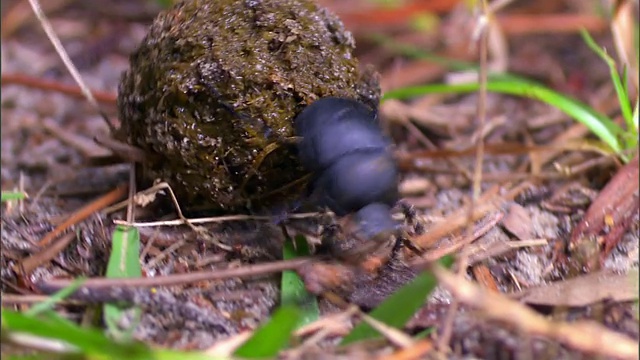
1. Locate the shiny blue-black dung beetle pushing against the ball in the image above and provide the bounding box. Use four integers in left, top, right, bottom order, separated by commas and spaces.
294, 97, 398, 239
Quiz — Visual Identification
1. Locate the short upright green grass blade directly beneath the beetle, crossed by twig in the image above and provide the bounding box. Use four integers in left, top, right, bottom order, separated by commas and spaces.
280, 235, 320, 328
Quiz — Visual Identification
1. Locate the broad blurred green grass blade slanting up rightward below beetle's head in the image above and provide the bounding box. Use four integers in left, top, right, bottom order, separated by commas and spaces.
341, 257, 453, 345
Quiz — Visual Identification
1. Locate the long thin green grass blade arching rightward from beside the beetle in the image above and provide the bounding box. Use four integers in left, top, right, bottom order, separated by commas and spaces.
383, 76, 623, 153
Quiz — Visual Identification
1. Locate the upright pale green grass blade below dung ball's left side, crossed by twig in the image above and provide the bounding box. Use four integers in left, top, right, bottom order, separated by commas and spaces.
103, 226, 142, 340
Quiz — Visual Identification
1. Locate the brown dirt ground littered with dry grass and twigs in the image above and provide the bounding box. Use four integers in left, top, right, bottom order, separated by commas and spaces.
0, 0, 640, 359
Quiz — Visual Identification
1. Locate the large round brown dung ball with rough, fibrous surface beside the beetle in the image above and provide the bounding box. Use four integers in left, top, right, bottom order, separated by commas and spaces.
118, 0, 380, 210
